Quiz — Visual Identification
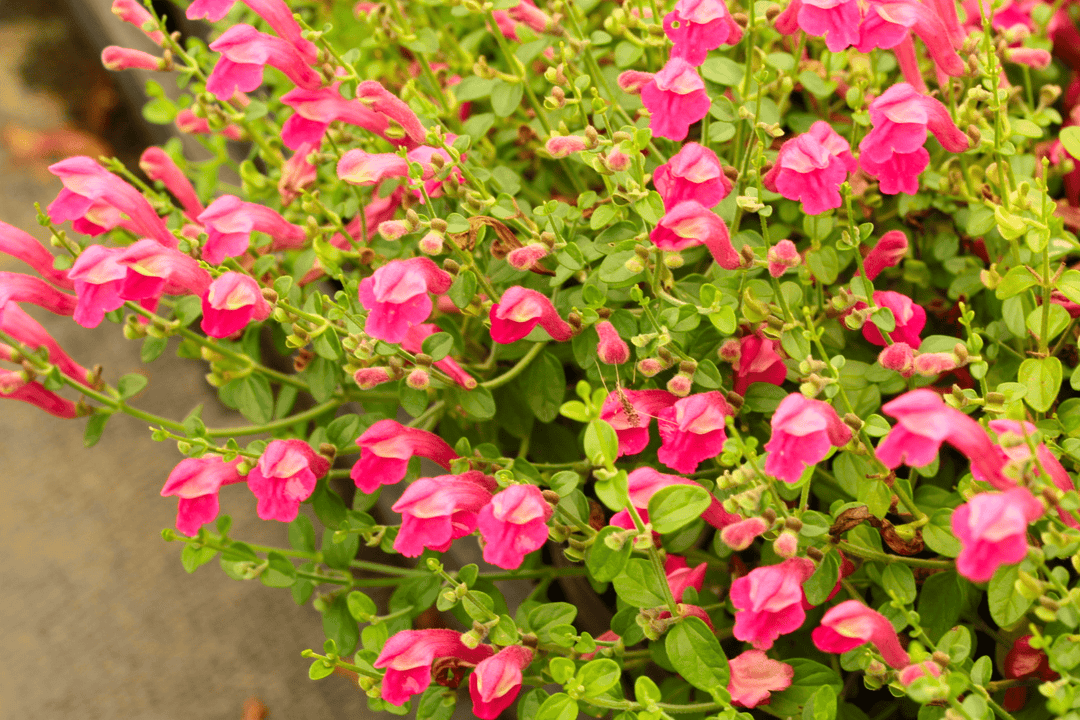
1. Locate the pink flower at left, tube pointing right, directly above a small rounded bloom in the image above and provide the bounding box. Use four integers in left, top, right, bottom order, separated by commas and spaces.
199, 195, 308, 264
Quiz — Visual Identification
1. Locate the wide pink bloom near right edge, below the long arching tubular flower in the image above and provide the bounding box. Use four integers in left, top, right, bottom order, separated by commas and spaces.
953, 488, 1044, 583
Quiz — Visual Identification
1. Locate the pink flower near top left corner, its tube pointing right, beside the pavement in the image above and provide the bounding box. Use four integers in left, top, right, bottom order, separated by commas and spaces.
206, 23, 323, 101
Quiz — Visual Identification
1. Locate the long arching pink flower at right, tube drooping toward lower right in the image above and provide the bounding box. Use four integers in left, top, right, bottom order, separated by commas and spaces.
877, 389, 1009, 486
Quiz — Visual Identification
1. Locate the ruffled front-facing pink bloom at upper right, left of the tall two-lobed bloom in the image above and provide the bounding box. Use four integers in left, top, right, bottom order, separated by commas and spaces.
761, 120, 858, 215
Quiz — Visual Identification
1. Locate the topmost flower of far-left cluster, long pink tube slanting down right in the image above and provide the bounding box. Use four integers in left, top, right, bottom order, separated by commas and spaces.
45, 155, 177, 247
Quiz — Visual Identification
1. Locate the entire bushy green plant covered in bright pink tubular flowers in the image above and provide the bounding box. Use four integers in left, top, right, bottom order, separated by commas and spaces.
0, 0, 1080, 720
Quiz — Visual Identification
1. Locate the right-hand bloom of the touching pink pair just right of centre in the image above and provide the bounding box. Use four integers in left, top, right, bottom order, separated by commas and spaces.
657, 390, 734, 475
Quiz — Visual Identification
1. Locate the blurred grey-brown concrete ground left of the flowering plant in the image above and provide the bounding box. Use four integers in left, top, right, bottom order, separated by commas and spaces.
0, 5, 367, 720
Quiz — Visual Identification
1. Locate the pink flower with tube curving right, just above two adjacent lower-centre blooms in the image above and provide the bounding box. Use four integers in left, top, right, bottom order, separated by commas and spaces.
350, 420, 458, 494
